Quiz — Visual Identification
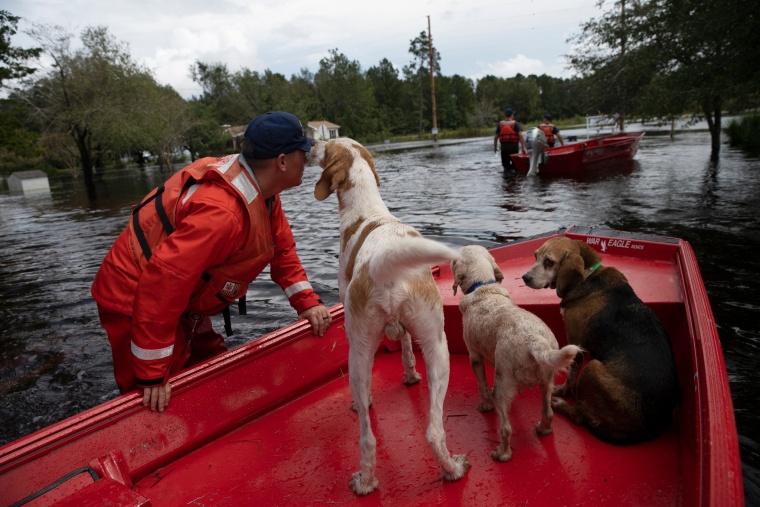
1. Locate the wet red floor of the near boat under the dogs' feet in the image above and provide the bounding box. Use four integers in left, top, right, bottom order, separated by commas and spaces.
133, 352, 680, 506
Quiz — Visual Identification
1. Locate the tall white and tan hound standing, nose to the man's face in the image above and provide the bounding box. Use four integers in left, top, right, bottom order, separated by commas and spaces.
311, 138, 470, 495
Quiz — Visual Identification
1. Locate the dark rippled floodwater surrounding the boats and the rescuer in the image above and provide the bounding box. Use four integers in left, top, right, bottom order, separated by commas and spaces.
0, 132, 760, 505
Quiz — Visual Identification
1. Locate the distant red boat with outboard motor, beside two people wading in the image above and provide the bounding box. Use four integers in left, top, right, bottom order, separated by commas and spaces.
511, 132, 644, 176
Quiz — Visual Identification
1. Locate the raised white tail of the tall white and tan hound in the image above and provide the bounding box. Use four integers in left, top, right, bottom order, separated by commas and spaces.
369, 237, 460, 283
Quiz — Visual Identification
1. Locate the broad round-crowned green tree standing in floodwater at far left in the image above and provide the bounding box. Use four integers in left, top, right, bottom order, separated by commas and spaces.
20, 26, 189, 190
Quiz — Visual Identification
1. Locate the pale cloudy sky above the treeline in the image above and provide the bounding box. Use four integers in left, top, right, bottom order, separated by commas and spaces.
0, 0, 611, 98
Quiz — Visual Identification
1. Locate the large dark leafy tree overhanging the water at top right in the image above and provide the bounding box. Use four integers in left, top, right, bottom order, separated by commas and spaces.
570, 0, 760, 156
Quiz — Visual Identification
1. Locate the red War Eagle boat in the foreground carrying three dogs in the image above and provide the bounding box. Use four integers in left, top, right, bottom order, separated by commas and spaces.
0, 227, 744, 507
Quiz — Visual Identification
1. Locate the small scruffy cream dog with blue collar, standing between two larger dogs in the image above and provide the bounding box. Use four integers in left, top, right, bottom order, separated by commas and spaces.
451, 245, 581, 461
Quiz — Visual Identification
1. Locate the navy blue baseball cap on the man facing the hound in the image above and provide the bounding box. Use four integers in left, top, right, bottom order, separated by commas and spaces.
245, 111, 314, 159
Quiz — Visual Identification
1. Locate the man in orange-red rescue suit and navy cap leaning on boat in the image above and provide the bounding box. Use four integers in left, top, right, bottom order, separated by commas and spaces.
92, 111, 331, 411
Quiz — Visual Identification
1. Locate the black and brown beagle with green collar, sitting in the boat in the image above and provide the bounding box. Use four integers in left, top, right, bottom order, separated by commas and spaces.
522, 237, 680, 444
